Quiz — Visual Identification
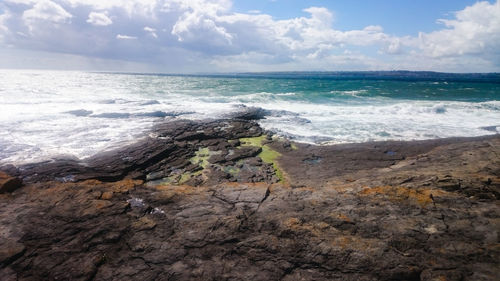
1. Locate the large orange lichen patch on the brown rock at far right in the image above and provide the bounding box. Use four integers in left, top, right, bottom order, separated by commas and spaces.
359, 186, 449, 206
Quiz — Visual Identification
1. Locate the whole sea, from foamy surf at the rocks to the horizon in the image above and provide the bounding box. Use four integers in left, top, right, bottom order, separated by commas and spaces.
0, 70, 500, 165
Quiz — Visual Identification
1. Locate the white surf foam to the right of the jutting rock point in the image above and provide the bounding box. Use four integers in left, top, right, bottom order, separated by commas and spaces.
241, 98, 500, 143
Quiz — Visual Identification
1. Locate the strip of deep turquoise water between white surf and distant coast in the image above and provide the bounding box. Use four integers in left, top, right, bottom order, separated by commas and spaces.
154, 77, 500, 104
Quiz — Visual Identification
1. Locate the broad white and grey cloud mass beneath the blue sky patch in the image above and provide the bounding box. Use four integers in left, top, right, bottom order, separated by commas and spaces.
0, 0, 500, 71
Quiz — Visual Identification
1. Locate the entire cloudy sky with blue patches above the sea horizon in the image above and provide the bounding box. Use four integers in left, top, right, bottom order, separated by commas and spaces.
0, 0, 500, 73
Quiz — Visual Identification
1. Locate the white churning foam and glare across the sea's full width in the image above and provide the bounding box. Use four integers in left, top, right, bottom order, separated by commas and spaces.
0, 70, 500, 164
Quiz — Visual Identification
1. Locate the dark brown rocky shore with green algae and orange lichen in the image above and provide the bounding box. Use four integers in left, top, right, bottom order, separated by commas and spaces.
0, 116, 500, 280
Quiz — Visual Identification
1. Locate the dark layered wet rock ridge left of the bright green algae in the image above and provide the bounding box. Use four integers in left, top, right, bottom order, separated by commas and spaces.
14, 120, 262, 182
